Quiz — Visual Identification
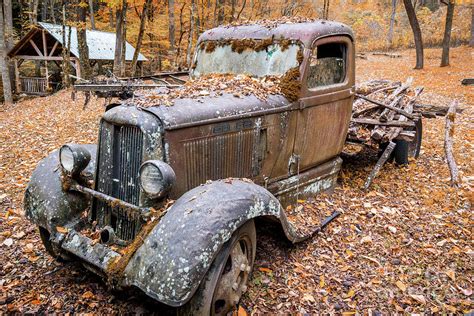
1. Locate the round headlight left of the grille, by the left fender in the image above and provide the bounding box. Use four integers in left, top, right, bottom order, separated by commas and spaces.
59, 144, 91, 176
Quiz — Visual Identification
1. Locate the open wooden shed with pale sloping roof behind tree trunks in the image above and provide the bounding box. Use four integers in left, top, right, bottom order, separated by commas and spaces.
8, 22, 147, 95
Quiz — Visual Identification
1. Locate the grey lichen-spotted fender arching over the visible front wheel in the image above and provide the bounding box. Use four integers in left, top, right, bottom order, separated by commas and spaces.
124, 179, 307, 306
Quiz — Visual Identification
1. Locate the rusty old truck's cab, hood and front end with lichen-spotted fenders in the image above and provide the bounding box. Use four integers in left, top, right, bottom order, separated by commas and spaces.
25, 21, 354, 315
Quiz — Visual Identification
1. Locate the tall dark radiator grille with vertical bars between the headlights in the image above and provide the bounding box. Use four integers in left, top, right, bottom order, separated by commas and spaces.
94, 122, 143, 240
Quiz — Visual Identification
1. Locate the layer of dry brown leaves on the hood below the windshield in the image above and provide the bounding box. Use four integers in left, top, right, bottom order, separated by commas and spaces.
128, 74, 281, 107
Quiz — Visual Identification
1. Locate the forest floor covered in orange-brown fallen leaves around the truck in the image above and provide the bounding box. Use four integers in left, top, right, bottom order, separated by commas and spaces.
0, 47, 474, 315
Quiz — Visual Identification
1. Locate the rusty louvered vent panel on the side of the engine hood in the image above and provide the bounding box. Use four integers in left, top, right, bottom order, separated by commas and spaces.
184, 130, 255, 189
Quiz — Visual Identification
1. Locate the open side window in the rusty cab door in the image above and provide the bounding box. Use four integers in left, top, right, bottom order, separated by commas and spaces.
307, 43, 347, 89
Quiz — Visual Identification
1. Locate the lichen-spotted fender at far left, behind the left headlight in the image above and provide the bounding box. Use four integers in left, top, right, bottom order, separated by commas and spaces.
24, 145, 97, 231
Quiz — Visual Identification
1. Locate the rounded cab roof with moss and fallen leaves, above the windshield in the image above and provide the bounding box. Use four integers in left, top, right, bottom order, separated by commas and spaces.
199, 20, 353, 47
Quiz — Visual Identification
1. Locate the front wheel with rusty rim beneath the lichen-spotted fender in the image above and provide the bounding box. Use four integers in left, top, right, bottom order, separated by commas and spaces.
178, 220, 257, 316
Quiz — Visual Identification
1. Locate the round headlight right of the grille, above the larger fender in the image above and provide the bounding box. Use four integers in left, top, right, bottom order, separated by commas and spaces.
140, 160, 176, 198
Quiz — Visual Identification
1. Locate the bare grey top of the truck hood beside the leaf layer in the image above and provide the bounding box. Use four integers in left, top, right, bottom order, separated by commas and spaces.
144, 93, 292, 130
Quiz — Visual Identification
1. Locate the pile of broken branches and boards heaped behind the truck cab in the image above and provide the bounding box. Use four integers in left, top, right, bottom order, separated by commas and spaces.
348, 77, 423, 146
